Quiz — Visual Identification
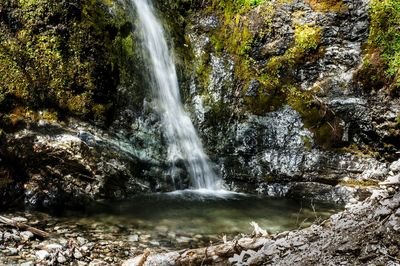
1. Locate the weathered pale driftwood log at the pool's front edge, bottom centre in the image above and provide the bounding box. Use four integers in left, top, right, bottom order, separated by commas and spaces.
123, 237, 267, 266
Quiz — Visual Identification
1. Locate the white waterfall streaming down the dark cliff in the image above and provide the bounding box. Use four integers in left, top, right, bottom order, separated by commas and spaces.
132, 0, 222, 190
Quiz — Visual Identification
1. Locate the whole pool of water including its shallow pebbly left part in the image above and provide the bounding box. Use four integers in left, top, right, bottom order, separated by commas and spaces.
0, 191, 341, 262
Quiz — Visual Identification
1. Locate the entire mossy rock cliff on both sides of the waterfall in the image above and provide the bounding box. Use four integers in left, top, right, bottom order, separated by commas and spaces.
0, 0, 400, 207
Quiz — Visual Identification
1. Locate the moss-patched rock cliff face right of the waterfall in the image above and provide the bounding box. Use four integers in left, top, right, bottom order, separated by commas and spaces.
173, 1, 399, 197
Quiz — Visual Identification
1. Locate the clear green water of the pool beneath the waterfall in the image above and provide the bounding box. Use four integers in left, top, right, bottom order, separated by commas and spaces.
64, 191, 340, 235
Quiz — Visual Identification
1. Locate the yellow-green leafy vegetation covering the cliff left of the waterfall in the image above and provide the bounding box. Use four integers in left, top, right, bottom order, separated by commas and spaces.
0, 0, 138, 125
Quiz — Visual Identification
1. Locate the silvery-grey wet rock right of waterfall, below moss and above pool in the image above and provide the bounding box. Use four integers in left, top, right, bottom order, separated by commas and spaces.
218, 106, 388, 201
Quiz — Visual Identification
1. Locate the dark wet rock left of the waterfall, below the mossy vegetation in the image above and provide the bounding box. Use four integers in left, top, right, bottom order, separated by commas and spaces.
0, 117, 171, 208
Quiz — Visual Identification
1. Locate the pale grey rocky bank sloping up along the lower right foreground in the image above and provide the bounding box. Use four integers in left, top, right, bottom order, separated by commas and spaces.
124, 187, 400, 266
